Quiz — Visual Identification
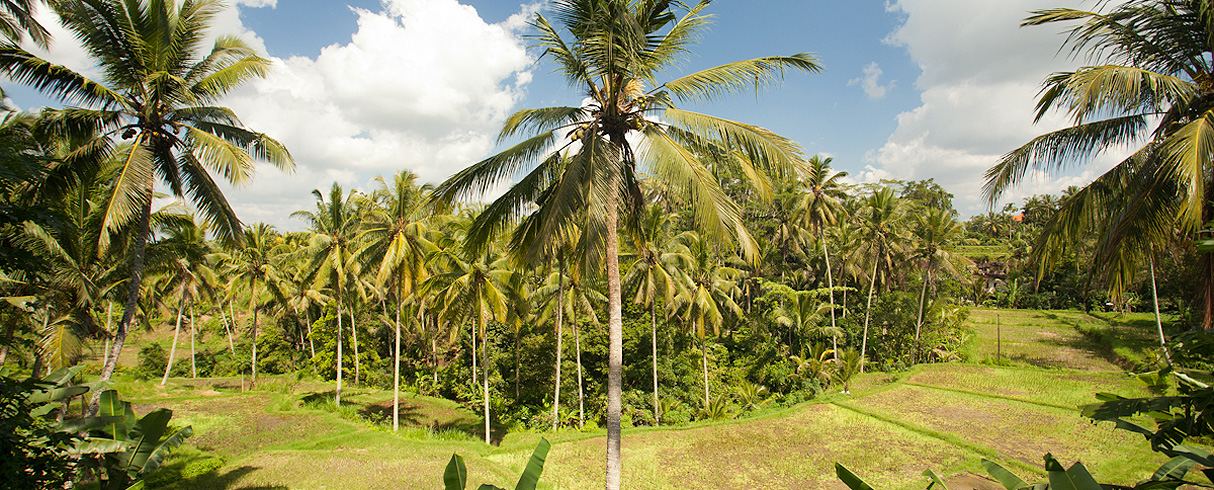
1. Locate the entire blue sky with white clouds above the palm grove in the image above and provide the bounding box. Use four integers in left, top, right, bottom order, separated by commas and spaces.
4, 0, 1113, 229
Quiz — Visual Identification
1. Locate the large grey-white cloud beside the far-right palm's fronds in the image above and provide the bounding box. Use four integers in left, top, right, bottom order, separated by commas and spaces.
862, 0, 1116, 215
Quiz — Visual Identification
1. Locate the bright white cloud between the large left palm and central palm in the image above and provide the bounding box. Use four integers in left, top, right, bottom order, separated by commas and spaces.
212, 0, 534, 228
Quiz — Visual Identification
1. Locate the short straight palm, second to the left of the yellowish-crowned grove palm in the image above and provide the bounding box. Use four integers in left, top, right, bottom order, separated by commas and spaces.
223, 223, 285, 389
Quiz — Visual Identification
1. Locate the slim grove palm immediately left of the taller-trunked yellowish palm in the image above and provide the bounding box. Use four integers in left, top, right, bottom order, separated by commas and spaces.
291, 182, 358, 406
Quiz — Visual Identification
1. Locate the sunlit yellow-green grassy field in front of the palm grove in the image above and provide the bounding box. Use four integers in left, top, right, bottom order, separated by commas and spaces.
111, 309, 1194, 490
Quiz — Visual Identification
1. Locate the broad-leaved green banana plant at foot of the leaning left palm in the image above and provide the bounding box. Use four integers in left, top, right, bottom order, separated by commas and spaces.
74, 389, 194, 490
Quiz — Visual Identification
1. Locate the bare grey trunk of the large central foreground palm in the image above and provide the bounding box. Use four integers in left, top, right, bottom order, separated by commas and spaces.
605, 194, 624, 490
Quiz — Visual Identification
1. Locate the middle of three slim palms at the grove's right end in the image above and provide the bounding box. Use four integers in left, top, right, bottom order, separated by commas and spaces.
860, 187, 904, 372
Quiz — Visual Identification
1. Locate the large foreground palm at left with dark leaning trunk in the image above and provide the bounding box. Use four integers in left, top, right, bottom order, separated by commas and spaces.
0, 0, 294, 412
